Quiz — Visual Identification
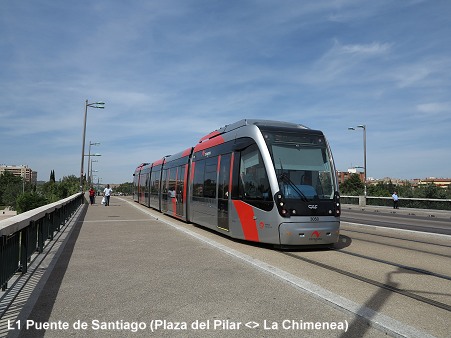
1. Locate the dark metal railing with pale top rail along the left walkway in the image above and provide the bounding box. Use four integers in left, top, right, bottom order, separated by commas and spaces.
0, 193, 85, 291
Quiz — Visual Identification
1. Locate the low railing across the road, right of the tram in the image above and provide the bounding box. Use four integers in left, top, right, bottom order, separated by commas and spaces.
340, 196, 451, 210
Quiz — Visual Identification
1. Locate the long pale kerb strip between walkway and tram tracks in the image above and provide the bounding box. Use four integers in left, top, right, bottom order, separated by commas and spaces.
123, 200, 433, 338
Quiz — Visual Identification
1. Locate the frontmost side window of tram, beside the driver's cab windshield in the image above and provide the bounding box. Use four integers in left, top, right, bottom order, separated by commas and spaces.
239, 145, 272, 201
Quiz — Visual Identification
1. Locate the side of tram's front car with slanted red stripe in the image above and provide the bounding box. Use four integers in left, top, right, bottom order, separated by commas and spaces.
189, 136, 279, 243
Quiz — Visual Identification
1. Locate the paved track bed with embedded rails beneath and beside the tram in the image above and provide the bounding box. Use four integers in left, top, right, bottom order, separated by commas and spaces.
127, 199, 451, 337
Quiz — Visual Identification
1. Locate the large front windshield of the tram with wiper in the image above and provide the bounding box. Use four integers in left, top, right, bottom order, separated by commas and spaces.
264, 133, 336, 201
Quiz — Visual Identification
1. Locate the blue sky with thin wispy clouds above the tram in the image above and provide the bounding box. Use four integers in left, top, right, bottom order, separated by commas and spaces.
0, 0, 451, 183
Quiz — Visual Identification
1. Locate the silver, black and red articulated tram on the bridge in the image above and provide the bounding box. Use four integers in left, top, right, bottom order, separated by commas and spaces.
133, 119, 341, 247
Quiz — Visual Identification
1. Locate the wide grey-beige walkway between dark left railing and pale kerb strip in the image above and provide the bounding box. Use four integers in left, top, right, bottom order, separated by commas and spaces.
3, 196, 416, 337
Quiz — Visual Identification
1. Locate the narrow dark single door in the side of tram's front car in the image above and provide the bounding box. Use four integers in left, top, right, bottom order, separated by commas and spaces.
217, 154, 231, 230
